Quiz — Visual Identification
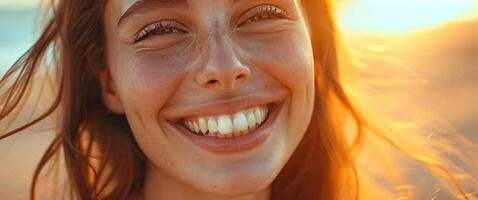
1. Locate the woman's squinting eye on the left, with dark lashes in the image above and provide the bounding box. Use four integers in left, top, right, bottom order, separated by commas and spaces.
134, 20, 188, 43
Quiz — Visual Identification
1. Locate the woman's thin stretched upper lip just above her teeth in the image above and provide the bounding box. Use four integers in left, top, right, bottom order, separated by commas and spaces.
166, 93, 285, 121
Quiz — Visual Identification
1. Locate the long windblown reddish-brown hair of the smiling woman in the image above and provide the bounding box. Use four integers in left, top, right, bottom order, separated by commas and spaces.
0, 0, 476, 200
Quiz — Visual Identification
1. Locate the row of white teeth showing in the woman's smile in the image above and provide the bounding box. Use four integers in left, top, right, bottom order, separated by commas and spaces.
183, 106, 269, 138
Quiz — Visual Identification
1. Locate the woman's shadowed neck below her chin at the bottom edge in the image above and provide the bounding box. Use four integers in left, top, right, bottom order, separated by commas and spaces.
134, 166, 270, 200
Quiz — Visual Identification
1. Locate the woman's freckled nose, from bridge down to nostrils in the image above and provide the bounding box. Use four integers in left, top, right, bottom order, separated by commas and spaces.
197, 20, 250, 89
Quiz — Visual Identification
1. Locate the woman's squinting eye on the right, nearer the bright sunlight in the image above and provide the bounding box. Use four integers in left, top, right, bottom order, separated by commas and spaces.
237, 4, 290, 27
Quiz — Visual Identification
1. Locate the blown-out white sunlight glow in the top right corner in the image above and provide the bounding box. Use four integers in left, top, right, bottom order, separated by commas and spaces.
337, 0, 478, 33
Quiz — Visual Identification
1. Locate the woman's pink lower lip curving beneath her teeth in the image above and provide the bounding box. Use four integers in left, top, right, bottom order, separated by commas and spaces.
170, 104, 282, 153
